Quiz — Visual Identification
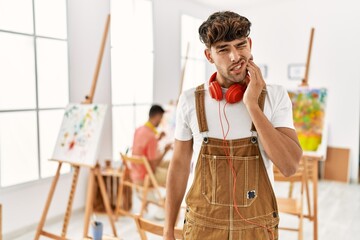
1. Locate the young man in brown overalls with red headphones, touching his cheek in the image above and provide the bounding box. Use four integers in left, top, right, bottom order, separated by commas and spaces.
164, 12, 302, 240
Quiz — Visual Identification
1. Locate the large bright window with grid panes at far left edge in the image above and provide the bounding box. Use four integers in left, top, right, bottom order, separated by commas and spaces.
0, 0, 70, 187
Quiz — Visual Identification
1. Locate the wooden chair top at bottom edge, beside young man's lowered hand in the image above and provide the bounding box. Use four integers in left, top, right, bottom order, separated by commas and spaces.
134, 215, 182, 240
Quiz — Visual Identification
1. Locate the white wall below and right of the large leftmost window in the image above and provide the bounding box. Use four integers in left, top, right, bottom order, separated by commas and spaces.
0, 0, 112, 236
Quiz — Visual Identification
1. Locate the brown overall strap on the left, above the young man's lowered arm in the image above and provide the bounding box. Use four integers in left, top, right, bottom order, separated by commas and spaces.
195, 84, 209, 133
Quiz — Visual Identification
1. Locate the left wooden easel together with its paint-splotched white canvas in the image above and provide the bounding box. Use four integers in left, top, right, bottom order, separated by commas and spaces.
34, 14, 117, 240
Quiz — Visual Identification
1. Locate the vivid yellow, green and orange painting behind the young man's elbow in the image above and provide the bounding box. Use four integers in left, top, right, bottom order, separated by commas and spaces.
288, 88, 327, 151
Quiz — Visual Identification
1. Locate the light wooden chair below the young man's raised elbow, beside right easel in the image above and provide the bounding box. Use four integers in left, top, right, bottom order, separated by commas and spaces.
274, 159, 310, 240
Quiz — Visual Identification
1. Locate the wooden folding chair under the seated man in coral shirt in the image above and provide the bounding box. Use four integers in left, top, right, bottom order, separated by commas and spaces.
115, 153, 165, 218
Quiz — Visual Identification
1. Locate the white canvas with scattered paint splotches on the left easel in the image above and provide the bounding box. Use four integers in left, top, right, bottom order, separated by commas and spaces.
52, 104, 107, 166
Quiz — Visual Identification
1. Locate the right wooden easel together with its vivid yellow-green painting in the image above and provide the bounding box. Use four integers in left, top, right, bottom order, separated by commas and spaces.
288, 28, 320, 240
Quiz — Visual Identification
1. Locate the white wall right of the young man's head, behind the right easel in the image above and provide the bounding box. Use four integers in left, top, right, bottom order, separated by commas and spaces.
236, 0, 360, 181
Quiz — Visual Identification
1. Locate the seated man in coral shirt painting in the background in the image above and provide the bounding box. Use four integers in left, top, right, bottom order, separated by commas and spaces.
130, 105, 171, 186
